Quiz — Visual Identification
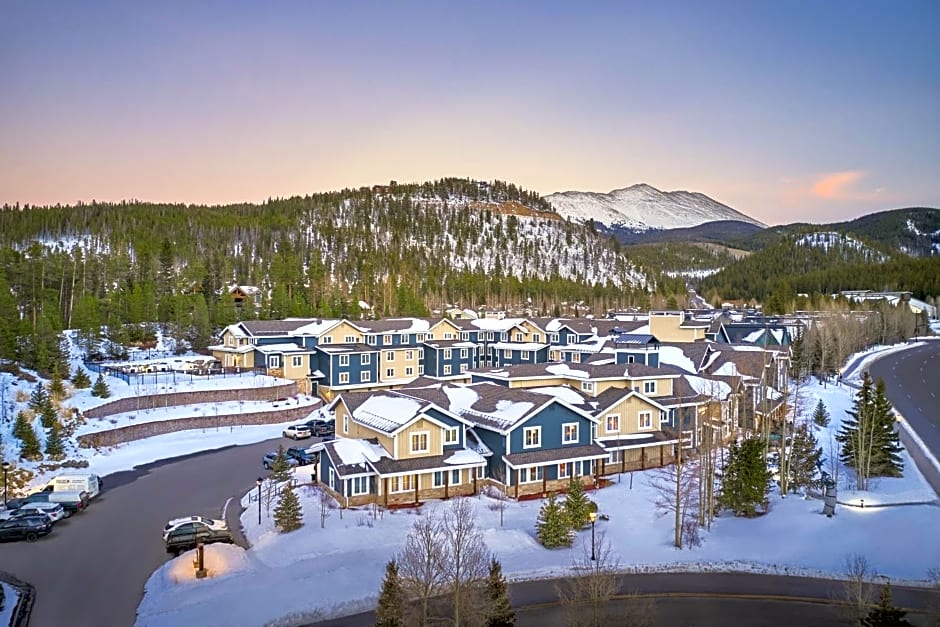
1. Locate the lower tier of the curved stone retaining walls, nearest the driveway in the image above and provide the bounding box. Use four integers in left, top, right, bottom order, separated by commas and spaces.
78, 404, 319, 448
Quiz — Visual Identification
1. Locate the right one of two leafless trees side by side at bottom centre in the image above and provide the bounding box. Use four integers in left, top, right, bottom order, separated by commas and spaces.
441, 497, 492, 627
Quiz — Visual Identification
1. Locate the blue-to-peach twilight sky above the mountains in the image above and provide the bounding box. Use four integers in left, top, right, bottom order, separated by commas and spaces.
0, 0, 940, 224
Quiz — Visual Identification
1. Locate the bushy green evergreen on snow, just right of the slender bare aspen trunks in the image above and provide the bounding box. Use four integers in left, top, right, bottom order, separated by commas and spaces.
718, 438, 771, 517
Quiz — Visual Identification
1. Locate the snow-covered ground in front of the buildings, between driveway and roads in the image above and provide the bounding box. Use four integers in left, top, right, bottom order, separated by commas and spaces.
137, 370, 940, 627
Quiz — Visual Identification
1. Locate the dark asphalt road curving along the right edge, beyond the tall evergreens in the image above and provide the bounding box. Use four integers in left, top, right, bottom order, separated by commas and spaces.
868, 341, 940, 496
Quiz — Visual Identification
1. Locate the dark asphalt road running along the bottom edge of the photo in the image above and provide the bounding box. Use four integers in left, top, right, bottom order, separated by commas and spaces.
317, 573, 940, 627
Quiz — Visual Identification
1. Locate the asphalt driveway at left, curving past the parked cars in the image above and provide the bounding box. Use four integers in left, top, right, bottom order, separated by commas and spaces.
0, 438, 302, 627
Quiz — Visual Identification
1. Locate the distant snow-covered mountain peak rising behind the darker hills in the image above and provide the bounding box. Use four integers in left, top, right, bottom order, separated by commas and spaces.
545, 184, 766, 231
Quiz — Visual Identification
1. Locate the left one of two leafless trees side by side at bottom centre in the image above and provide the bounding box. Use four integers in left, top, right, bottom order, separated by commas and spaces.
398, 512, 445, 625
